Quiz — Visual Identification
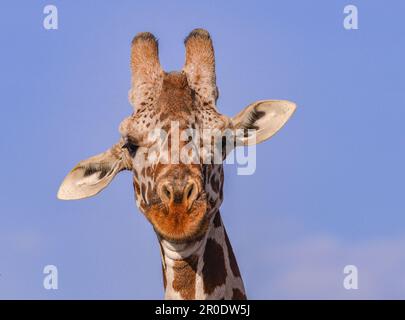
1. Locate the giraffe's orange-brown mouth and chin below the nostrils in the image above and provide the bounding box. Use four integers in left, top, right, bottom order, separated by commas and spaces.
145, 197, 210, 243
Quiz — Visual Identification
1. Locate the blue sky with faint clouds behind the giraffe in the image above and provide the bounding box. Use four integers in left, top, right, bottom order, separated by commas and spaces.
0, 0, 405, 299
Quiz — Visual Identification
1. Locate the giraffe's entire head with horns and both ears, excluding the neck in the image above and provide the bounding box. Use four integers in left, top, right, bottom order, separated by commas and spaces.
58, 29, 295, 243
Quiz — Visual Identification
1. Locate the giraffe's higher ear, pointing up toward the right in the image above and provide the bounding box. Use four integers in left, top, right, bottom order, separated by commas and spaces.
232, 100, 296, 145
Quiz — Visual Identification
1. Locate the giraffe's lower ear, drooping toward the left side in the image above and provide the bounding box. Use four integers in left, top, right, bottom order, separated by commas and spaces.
57, 144, 126, 200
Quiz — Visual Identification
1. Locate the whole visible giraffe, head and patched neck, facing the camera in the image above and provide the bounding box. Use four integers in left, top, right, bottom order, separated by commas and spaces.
58, 29, 296, 299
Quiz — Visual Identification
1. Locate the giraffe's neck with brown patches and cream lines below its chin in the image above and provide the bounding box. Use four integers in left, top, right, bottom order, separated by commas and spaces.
160, 212, 246, 300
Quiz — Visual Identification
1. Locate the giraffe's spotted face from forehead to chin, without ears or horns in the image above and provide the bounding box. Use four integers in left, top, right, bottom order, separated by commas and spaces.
120, 72, 229, 242
